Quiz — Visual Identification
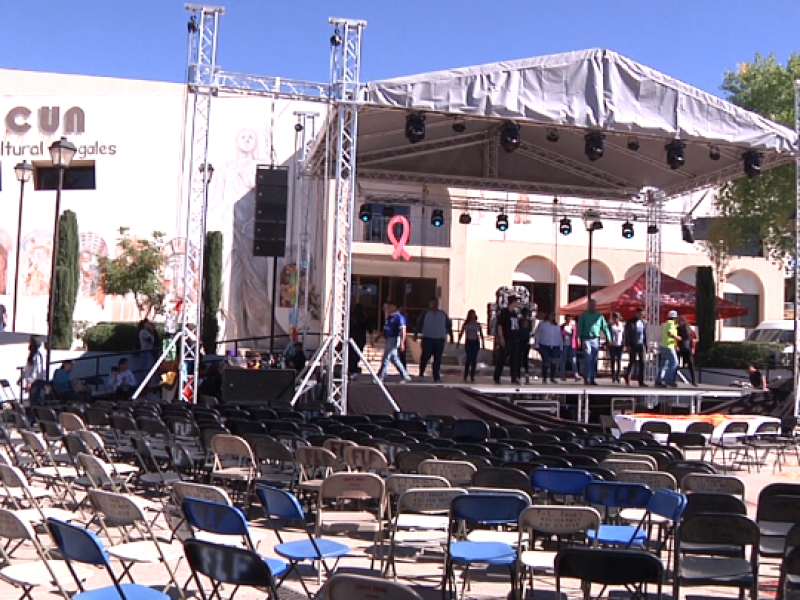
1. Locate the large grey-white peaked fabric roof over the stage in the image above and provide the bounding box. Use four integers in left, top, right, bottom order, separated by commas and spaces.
324, 50, 797, 200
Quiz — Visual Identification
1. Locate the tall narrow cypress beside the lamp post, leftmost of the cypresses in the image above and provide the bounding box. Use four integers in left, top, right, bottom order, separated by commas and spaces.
51, 210, 80, 350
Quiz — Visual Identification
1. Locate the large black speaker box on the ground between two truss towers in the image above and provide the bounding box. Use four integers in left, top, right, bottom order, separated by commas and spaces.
222, 368, 297, 406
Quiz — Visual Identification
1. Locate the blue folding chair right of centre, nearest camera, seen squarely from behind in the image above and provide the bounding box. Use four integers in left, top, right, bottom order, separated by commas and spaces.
442, 493, 530, 597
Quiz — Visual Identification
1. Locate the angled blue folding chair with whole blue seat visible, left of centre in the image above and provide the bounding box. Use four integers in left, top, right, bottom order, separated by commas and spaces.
256, 485, 350, 598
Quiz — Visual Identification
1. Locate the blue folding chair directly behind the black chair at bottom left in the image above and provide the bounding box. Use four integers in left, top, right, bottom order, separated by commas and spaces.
181, 498, 289, 575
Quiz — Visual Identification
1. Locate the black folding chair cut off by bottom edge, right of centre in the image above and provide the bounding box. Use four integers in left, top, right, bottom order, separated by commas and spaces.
555, 548, 664, 600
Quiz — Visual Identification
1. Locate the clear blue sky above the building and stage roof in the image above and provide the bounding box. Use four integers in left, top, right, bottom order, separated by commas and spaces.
0, 0, 800, 94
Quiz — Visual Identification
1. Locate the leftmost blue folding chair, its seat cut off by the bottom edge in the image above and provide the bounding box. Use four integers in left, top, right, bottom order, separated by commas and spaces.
47, 518, 170, 600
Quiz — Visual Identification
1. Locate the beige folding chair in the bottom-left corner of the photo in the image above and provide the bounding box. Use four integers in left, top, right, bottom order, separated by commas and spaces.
0, 509, 91, 600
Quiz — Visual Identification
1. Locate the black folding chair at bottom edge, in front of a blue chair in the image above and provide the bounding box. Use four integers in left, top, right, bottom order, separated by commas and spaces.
183, 539, 285, 600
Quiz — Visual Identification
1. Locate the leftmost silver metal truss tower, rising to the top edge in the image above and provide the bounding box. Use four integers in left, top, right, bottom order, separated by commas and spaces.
180, 4, 220, 402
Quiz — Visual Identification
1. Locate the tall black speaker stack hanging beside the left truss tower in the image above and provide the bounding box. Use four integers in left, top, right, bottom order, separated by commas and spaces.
253, 167, 289, 257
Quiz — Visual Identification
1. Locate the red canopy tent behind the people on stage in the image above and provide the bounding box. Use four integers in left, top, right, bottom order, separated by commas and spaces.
561, 271, 747, 323
